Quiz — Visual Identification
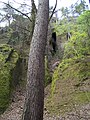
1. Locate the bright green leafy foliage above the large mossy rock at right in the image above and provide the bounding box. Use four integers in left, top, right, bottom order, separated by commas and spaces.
64, 10, 90, 58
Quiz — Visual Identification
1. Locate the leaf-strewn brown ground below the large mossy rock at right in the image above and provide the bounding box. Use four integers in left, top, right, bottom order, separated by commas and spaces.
44, 104, 90, 120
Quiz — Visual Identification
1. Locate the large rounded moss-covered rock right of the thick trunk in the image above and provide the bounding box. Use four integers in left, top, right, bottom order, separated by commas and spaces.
45, 56, 90, 115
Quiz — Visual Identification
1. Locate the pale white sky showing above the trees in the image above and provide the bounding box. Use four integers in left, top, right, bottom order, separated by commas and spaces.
0, 0, 90, 26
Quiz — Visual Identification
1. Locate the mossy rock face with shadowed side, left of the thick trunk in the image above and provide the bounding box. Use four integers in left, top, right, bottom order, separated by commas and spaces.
0, 44, 21, 114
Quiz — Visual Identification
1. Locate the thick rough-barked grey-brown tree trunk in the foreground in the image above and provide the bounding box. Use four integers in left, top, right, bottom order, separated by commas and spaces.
23, 0, 49, 120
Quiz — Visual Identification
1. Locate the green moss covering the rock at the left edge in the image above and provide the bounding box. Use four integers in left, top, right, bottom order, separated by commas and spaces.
0, 44, 19, 113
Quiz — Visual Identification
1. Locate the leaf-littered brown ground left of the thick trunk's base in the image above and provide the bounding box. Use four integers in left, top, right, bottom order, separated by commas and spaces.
0, 88, 25, 120
